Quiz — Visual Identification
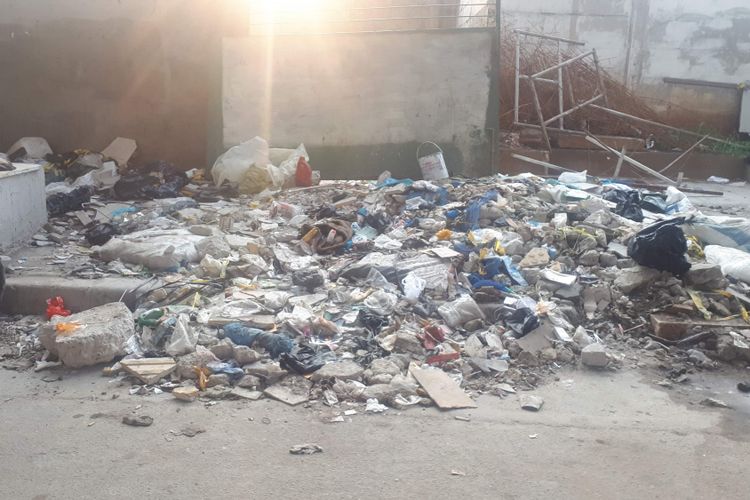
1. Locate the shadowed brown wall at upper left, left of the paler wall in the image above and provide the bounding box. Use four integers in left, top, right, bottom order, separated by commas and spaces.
0, 0, 247, 168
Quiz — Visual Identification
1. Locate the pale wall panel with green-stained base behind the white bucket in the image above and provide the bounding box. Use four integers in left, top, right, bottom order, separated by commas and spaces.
223, 30, 497, 178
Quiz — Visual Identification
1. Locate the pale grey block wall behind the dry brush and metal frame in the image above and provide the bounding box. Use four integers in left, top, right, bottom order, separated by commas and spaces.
500, 0, 750, 132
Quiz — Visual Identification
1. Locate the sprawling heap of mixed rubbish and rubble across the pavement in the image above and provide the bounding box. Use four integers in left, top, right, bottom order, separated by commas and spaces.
3, 138, 750, 414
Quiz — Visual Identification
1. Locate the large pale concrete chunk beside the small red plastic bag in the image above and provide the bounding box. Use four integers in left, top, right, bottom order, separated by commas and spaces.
39, 302, 135, 368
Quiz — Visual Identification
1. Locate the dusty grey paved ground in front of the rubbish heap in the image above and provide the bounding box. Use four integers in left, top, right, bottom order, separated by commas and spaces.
0, 369, 750, 499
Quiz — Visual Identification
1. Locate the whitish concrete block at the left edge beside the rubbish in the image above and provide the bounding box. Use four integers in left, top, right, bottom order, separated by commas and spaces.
0, 163, 47, 252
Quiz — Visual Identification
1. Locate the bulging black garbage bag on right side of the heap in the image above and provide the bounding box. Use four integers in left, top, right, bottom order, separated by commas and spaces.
628, 217, 690, 277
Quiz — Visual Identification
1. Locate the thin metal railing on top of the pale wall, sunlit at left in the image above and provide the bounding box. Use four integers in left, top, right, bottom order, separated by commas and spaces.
249, 0, 496, 35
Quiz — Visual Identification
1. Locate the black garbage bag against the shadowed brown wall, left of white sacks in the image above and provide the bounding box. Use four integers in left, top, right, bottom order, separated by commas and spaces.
114, 161, 189, 200
